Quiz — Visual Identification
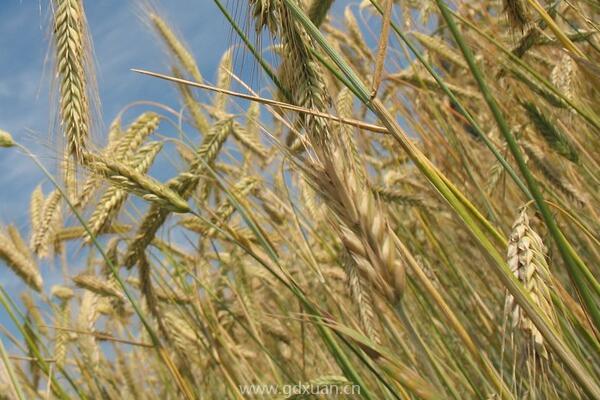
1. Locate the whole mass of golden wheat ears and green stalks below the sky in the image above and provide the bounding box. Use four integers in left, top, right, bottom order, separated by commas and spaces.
0, 0, 600, 400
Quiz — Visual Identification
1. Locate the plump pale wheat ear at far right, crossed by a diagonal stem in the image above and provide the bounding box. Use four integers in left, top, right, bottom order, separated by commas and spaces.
505, 208, 557, 359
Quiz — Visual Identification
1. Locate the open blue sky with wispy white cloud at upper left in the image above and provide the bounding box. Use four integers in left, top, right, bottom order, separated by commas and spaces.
0, 0, 232, 230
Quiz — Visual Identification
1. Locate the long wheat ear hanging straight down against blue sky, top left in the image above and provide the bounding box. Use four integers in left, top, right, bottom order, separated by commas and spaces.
52, 0, 91, 161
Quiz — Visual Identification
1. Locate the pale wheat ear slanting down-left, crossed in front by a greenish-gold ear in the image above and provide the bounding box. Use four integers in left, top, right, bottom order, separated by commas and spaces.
84, 142, 162, 242
